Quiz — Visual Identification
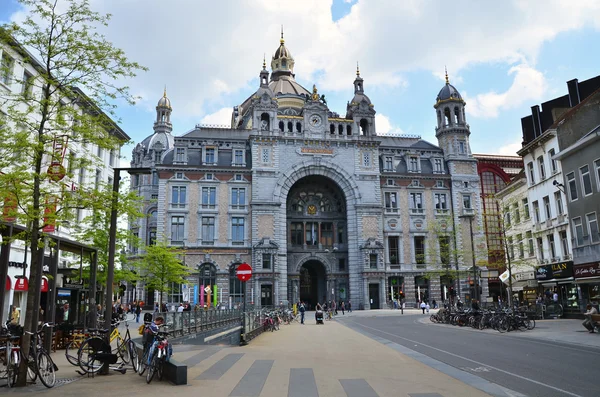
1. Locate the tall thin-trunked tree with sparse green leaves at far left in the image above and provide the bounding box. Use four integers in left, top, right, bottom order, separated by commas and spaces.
0, 0, 145, 386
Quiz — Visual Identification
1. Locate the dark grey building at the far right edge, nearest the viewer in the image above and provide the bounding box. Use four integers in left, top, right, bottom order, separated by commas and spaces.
555, 89, 600, 310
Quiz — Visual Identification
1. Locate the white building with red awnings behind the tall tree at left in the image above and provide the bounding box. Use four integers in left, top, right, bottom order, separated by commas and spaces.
0, 34, 129, 324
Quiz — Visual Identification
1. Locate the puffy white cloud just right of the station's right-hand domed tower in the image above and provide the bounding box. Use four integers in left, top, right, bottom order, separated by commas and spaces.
464, 64, 547, 118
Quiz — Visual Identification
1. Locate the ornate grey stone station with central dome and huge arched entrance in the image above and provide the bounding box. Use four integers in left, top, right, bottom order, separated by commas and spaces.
129, 33, 488, 309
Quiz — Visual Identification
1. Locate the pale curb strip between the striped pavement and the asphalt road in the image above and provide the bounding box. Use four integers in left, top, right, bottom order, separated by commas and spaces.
338, 321, 527, 397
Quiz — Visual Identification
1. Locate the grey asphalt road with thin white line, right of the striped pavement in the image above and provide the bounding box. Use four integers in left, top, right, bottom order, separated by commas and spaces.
340, 316, 600, 397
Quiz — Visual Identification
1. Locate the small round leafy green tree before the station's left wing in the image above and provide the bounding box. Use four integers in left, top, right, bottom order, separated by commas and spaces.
135, 242, 190, 305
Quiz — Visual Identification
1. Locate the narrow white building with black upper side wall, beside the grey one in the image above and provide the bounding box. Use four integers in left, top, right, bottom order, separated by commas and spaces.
518, 76, 600, 315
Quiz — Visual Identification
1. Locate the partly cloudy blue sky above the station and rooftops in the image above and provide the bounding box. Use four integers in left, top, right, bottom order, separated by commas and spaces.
0, 0, 600, 162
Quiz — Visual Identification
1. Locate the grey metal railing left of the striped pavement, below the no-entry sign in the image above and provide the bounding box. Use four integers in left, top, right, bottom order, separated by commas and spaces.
154, 309, 242, 336
